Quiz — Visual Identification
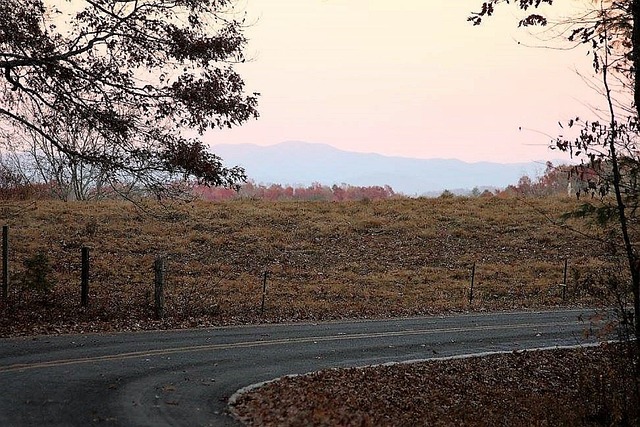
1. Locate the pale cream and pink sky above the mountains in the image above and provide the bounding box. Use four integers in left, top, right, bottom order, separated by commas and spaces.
211, 0, 601, 163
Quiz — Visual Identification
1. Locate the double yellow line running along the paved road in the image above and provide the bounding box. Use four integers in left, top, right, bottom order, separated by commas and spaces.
0, 321, 579, 373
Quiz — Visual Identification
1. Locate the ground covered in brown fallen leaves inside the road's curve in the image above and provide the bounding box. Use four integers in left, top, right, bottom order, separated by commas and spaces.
232, 346, 640, 426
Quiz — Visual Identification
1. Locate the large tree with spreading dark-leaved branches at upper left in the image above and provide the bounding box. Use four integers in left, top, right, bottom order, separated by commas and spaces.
0, 0, 258, 196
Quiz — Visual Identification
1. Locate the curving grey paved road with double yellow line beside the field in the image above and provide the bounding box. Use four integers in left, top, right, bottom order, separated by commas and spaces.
0, 310, 608, 426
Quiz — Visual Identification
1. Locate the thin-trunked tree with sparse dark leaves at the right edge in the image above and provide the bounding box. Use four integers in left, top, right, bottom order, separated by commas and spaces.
468, 0, 640, 364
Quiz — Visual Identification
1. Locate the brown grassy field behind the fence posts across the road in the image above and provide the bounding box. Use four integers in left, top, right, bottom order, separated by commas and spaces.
0, 197, 613, 336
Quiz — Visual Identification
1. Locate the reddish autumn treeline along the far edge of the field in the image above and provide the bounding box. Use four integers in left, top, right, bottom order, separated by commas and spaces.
0, 158, 584, 202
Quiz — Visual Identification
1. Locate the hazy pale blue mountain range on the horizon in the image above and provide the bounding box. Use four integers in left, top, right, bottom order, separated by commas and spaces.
213, 141, 544, 196
